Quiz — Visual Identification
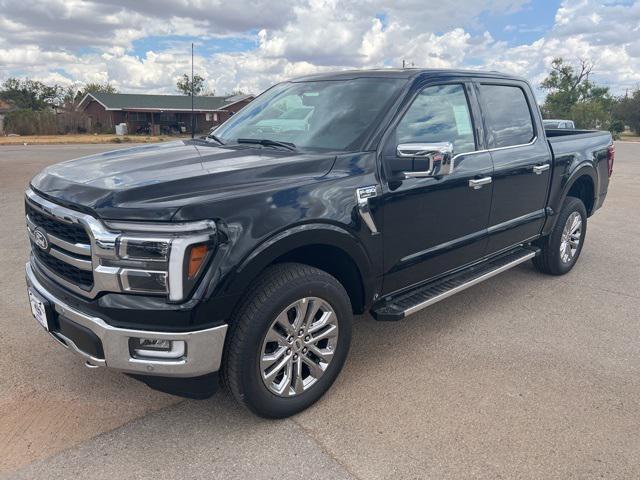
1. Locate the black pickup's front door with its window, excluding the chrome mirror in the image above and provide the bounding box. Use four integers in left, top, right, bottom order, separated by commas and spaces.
381, 82, 493, 294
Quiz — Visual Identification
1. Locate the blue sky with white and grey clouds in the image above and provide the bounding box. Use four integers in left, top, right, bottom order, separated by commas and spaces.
0, 0, 640, 98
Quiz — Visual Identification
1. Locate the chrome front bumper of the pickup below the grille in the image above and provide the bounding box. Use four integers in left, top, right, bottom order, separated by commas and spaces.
26, 263, 227, 377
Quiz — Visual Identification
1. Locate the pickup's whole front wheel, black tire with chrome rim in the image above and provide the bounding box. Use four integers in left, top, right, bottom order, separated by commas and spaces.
223, 263, 352, 418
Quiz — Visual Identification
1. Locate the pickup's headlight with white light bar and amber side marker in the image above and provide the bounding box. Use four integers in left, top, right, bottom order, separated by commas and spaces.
101, 220, 216, 302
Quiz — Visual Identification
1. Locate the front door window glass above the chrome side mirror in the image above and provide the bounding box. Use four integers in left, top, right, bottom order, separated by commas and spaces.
396, 84, 476, 155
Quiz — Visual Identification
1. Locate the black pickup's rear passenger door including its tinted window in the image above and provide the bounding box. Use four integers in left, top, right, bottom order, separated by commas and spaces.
476, 79, 552, 254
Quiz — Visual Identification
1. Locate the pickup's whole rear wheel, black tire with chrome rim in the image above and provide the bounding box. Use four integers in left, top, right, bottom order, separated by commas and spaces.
533, 197, 587, 275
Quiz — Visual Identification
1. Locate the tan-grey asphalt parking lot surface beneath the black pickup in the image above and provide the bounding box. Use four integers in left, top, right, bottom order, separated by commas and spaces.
0, 143, 640, 479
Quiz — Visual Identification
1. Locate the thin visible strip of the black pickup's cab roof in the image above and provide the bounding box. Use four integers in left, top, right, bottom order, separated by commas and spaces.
291, 68, 524, 82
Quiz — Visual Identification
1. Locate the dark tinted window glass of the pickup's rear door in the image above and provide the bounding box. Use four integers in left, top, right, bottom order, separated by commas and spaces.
480, 85, 534, 148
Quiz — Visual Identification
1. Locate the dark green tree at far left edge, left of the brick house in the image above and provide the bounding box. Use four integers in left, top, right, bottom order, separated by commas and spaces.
0, 78, 63, 111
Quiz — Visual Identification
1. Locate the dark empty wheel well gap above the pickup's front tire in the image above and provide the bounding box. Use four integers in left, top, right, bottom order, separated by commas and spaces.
273, 245, 364, 313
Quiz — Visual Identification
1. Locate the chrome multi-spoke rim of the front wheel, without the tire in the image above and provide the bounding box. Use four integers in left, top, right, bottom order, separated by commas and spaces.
260, 297, 338, 397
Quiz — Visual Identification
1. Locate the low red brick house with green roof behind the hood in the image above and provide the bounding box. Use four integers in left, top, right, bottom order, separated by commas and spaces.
78, 93, 254, 135
